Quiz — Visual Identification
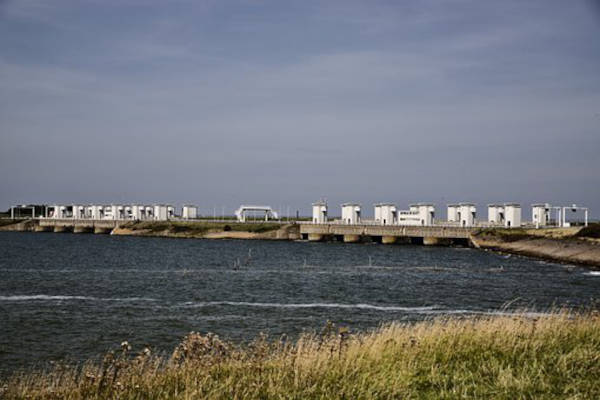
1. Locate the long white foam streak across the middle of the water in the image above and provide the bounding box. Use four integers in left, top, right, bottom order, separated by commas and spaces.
178, 301, 436, 312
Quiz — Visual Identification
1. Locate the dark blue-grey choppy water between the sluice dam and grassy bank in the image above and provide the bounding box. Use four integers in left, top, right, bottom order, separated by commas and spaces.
0, 232, 600, 373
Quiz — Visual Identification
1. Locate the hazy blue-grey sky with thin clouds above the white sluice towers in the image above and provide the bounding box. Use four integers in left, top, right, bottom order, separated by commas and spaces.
0, 0, 600, 218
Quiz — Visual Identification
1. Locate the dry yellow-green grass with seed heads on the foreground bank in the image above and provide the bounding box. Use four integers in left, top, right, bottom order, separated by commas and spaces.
0, 312, 600, 399
